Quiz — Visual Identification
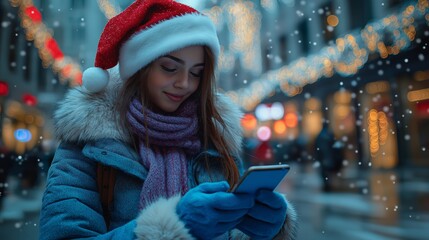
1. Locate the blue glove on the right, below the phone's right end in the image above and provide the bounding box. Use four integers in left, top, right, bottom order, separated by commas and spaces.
237, 190, 287, 239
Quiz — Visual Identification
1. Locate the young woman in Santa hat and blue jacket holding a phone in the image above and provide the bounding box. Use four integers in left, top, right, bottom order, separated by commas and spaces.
40, 0, 296, 239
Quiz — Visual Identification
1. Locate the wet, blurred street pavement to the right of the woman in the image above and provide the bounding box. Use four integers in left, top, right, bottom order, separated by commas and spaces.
280, 162, 429, 240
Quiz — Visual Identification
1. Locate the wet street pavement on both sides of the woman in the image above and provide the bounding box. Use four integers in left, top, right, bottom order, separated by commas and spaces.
0, 164, 429, 240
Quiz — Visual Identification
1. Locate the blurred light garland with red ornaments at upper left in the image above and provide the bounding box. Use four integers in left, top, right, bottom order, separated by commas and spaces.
9, 0, 82, 86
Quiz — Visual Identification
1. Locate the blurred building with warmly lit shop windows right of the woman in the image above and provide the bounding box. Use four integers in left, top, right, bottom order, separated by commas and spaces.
209, 0, 429, 168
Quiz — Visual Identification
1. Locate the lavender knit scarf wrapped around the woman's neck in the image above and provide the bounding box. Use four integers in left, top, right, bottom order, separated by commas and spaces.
127, 99, 201, 209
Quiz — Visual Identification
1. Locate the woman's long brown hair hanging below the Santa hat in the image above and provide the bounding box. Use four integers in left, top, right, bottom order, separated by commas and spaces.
117, 47, 239, 186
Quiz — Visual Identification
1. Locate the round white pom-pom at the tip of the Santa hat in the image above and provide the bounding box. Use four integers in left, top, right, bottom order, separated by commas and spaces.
82, 67, 109, 93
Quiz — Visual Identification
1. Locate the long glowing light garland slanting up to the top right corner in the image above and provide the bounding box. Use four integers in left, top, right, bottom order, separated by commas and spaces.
228, 0, 429, 111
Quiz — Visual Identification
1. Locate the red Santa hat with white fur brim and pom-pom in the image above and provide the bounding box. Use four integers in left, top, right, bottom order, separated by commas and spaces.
82, 0, 220, 92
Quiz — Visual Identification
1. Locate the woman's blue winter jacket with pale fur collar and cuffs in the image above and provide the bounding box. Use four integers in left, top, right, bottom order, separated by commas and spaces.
40, 69, 296, 240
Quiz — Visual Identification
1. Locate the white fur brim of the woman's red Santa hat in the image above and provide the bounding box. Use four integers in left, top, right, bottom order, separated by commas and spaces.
119, 14, 220, 80
